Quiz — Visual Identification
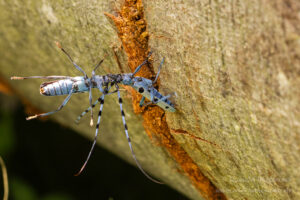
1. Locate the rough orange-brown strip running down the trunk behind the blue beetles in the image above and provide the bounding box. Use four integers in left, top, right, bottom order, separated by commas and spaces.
105, 0, 226, 199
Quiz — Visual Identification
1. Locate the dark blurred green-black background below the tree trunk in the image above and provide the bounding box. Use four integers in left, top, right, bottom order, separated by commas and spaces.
0, 93, 187, 200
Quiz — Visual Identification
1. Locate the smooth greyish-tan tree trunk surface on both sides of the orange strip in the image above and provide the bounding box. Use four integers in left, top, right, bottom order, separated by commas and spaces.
0, 0, 300, 200
